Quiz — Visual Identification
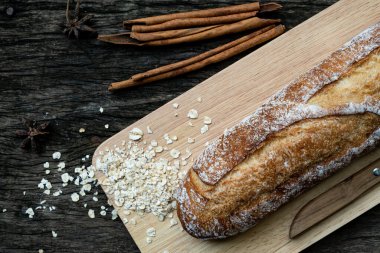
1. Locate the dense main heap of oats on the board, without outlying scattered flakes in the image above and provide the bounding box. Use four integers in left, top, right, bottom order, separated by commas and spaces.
96, 136, 180, 221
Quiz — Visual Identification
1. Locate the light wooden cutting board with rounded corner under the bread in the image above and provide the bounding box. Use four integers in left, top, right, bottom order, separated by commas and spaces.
93, 0, 380, 253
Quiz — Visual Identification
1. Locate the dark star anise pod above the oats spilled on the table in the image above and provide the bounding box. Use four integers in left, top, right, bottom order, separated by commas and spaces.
16, 119, 50, 152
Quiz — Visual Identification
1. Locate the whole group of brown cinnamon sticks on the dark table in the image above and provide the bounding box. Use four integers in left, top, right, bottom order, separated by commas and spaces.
98, 2, 285, 91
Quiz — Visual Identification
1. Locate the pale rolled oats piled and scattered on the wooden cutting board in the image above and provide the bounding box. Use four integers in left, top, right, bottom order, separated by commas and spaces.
95, 97, 212, 227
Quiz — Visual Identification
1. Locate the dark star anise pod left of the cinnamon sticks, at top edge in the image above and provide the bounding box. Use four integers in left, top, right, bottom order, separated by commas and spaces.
63, 0, 98, 39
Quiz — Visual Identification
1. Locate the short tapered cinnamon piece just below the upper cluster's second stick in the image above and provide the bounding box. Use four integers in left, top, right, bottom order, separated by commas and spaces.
130, 25, 220, 41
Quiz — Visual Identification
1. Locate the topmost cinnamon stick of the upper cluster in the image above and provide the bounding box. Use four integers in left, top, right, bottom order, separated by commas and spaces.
124, 2, 260, 27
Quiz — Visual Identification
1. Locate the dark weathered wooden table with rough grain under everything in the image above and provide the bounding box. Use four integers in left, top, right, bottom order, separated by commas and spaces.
0, 0, 380, 253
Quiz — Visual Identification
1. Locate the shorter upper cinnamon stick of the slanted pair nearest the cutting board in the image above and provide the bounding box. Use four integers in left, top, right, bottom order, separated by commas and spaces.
131, 25, 275, 81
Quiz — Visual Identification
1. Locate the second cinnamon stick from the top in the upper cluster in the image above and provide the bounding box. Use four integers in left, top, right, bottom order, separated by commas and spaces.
132, 11, 257, 33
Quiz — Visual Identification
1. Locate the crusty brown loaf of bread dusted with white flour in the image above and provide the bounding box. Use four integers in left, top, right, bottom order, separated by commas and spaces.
177, 23, 380, 239
